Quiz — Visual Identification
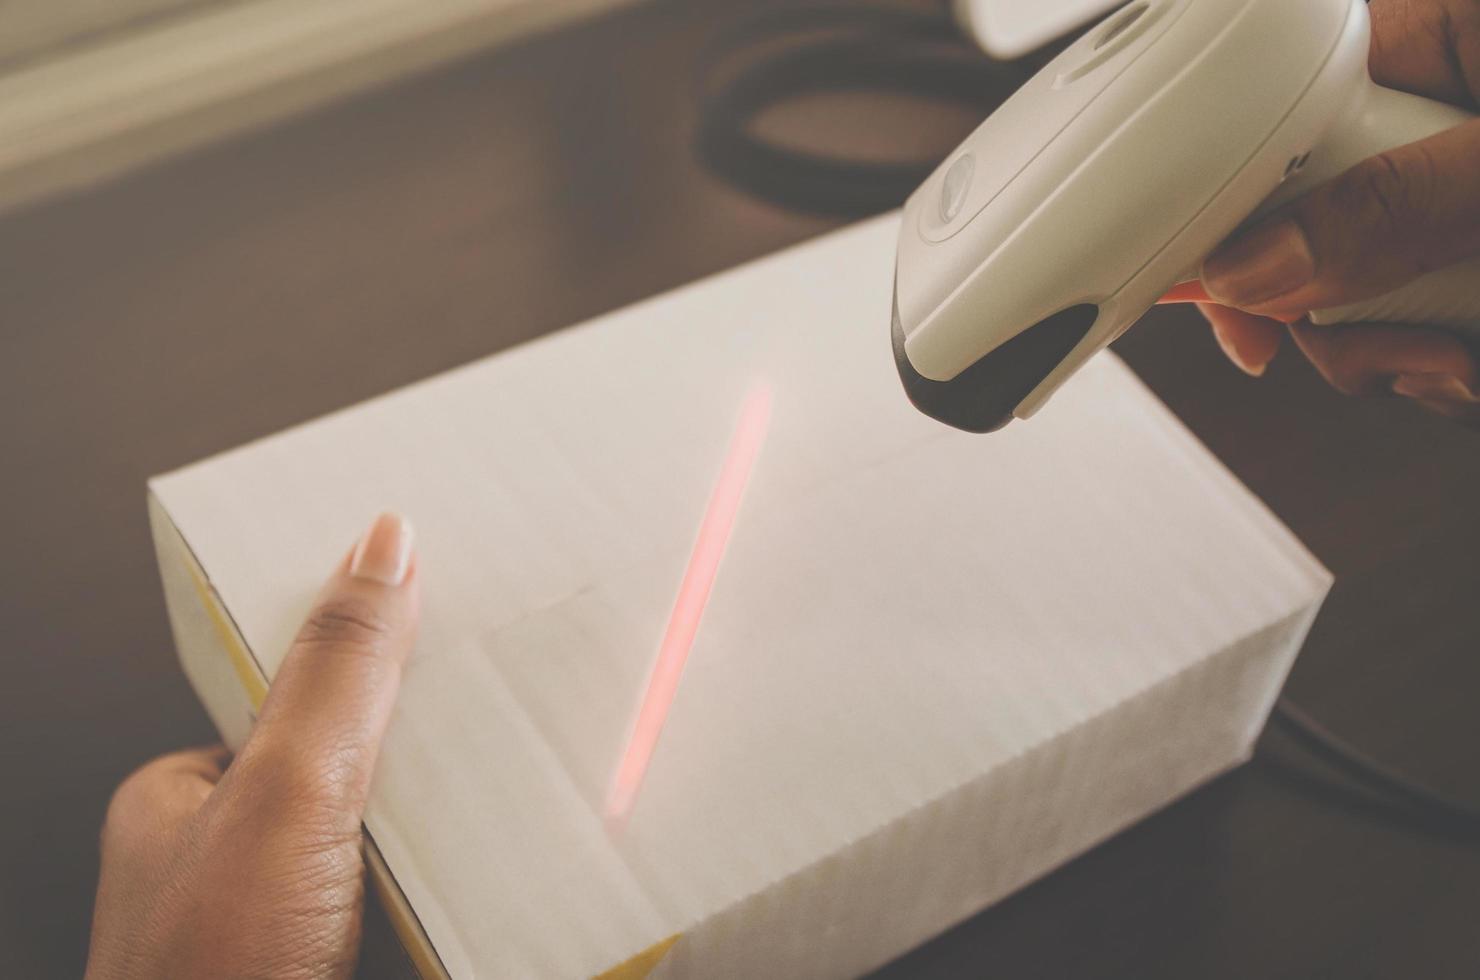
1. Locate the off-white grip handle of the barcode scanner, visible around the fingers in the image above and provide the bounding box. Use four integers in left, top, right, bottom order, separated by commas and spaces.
1261, 84, 1480, 340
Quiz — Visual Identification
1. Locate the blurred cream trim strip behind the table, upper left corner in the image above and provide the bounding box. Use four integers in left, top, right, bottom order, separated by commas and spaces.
0, 0, 632, 210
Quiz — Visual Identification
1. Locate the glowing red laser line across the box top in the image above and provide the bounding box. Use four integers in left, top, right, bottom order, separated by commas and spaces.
607, 388, 771, 820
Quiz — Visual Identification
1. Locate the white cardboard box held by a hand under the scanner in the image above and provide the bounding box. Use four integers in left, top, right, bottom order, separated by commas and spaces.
151, 216, 1331, 979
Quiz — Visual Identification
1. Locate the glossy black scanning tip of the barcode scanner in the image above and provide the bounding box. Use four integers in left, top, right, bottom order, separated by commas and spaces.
891, 296, 1100, 432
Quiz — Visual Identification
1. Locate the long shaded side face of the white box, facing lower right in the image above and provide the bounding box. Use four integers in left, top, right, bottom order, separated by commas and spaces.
653, 605, 1317, 980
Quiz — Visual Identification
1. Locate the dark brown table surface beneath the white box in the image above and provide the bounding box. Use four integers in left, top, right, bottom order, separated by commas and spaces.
0, 0, 1480, 979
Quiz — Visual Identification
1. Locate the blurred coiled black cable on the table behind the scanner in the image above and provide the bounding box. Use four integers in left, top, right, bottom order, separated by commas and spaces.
696, 4, 1026, 216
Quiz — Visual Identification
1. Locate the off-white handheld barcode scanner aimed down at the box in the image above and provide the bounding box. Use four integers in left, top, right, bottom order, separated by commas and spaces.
892, 0, 1480, 432
